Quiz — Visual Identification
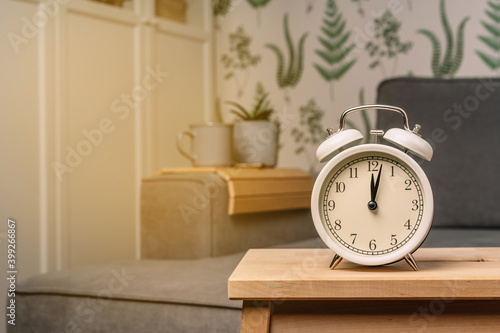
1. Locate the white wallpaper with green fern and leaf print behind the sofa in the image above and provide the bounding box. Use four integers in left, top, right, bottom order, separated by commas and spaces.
212, 0, 500, 174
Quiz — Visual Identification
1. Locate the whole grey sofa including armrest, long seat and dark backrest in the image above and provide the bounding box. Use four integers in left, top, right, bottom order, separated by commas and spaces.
8, 78, 500, 333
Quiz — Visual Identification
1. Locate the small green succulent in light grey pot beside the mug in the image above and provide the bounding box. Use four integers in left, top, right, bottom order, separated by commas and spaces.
226, 84, 279, 167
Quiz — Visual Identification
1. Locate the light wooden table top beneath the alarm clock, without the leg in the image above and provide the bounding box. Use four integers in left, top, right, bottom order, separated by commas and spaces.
228, 248, 500, 300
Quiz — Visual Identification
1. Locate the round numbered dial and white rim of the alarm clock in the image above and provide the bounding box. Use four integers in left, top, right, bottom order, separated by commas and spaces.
313, 145, 433, 264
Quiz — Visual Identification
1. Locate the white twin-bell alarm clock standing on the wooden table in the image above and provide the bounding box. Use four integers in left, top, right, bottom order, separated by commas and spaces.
311, 105, 434, 270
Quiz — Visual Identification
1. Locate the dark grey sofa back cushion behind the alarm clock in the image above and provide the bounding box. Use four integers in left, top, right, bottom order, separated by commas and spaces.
377, 78, 500, 228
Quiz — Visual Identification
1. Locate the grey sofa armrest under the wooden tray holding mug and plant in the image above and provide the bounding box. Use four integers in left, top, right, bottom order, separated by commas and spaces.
141, 173, 317, 259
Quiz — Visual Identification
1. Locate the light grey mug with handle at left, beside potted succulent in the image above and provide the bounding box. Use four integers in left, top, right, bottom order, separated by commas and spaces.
177, 123, 233, 166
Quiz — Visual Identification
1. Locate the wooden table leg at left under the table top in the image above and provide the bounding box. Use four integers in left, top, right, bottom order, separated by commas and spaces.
241, 301, 271, 333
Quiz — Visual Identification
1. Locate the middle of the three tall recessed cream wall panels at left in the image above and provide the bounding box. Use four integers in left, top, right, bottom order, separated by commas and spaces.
63, 13, 142, 266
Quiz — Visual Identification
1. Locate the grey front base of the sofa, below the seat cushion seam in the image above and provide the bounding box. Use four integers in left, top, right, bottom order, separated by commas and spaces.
14, 294, 241, 333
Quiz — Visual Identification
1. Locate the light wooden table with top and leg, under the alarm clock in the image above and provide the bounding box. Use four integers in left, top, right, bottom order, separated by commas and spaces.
228, 248, 500, 333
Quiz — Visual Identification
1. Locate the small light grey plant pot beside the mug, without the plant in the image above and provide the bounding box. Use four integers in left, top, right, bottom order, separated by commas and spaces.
233, 120, 279, 167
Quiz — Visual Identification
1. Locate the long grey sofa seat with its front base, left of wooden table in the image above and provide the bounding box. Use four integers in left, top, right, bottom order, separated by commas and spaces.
13, 238, 324, 333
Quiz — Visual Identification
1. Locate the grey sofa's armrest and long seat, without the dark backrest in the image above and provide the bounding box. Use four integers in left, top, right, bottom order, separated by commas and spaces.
13, 173, 322, 333
